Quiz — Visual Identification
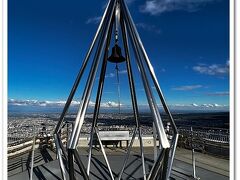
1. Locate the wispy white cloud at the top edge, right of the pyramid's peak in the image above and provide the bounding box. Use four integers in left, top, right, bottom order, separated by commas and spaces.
140, 0, 216, 15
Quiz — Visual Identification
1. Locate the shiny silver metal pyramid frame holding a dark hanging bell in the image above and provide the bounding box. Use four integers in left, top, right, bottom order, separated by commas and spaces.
54, 0, 178, 180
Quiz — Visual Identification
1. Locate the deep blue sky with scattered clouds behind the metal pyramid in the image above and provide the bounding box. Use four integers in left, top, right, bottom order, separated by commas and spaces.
8, 0, 229, 111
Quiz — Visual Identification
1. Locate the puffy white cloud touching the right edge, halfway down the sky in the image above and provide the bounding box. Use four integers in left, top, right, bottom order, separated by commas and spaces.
193, 61, 229, 76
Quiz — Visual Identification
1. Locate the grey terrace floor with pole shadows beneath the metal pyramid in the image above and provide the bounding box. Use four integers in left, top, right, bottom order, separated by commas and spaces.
8, 148, 229, 180
